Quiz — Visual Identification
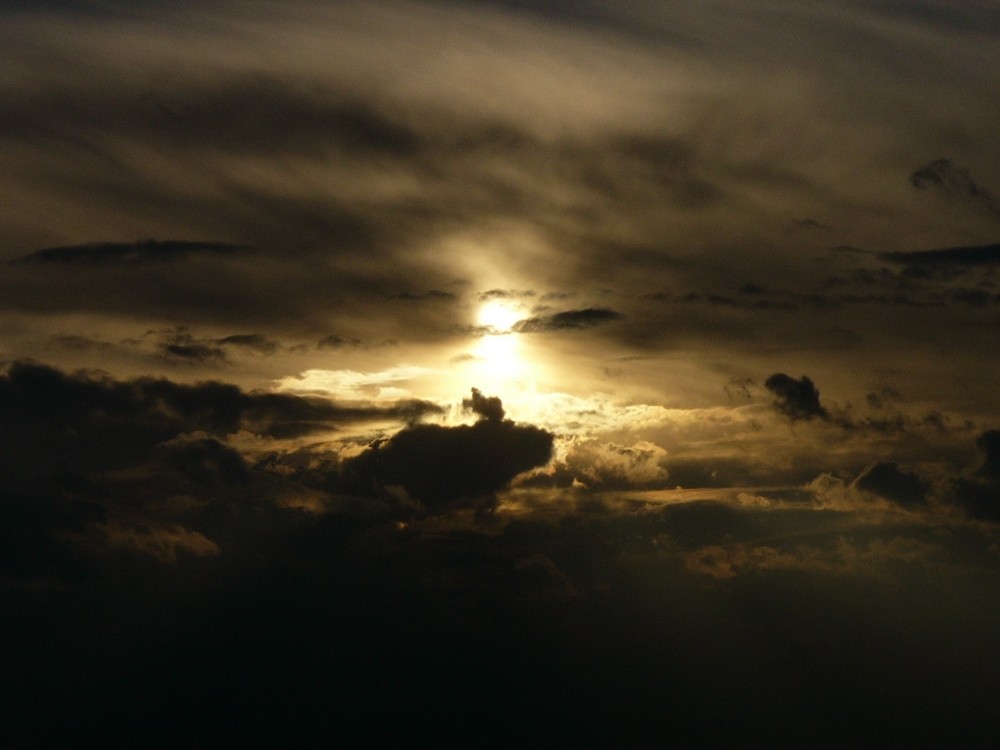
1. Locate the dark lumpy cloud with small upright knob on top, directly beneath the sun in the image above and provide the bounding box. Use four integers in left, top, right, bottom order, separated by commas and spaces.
344, 390, 555, 513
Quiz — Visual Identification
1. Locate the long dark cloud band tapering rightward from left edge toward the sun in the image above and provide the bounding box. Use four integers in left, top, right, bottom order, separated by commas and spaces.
0, 362, 441, 469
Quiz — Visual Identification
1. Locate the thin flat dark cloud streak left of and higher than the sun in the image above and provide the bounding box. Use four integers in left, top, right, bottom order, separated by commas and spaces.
11, 240, 249, 266
